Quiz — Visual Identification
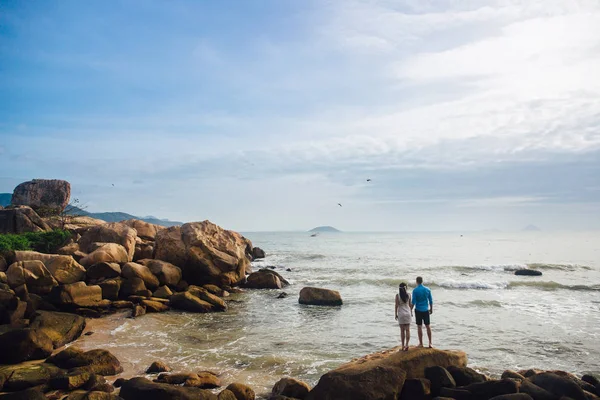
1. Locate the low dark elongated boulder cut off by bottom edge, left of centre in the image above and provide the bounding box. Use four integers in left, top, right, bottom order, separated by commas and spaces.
119, 378, 217, 400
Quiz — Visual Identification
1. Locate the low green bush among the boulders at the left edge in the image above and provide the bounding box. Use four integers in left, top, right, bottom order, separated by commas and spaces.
0, 229, 71, 254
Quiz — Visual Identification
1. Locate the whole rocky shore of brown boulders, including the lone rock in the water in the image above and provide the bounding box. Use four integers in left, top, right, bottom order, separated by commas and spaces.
0, 180, 600, 400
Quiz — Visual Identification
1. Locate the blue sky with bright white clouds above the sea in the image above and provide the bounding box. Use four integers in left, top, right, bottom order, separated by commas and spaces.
0, 0, 600, 231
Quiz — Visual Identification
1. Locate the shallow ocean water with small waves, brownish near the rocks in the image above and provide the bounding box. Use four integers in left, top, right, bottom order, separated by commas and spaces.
75, 232, 600, 395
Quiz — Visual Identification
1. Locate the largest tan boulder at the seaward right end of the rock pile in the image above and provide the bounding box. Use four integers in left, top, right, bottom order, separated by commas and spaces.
154, 221, 250, 286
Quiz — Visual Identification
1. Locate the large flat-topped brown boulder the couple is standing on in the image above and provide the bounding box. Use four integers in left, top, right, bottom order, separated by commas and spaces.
306, 348, 467, 400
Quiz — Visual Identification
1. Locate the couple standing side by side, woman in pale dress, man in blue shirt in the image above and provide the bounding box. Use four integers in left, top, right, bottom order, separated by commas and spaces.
394, 276, 433, 351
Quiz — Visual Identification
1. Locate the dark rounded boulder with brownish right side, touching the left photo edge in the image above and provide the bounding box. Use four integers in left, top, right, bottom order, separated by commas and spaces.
0, 329, 54, 364
